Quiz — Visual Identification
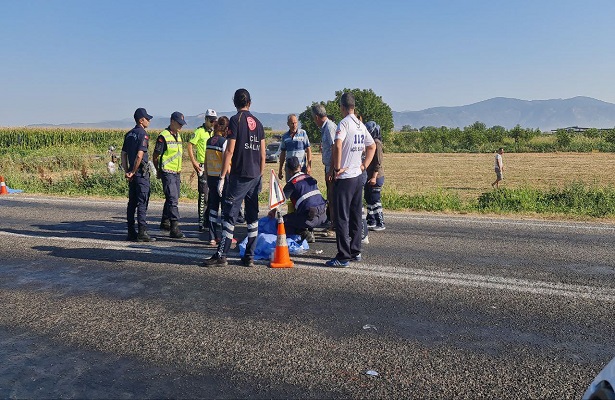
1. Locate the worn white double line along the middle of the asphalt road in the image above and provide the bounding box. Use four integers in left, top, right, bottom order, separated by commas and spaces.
0, 231, 615, 302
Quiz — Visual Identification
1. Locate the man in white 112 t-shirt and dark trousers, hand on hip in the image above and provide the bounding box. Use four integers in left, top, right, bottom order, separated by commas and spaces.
325, 92, 376, 268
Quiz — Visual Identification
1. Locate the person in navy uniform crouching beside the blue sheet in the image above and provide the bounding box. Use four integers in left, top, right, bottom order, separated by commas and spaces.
284, 157, 327, 243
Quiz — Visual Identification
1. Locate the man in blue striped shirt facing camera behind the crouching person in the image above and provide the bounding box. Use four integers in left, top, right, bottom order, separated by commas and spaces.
278, 114, 312, 181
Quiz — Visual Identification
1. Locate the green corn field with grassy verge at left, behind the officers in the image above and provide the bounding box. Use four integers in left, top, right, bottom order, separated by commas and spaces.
0, 127, 196, 198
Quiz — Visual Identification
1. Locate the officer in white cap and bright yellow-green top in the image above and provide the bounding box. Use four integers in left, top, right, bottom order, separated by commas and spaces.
188, 108, 218, 232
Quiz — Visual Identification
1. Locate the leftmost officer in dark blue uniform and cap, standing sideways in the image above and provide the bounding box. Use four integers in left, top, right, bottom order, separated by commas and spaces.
122, 108, 156, 242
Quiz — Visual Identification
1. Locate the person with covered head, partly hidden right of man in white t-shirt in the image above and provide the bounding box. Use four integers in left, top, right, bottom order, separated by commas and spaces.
364, 121, 385, 231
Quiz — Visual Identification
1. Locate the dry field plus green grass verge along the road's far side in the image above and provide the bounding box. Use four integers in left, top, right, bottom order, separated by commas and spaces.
0, 144, 615, 219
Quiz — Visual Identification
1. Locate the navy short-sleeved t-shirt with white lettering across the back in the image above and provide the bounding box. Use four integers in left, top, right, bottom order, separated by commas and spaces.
226, 111, 265, 178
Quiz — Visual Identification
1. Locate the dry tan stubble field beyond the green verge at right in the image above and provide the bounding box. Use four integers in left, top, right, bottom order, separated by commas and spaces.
182, 153, 615, 199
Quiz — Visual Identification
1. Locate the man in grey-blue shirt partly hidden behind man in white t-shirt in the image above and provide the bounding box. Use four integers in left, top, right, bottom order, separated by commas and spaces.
312, 104, 337, 236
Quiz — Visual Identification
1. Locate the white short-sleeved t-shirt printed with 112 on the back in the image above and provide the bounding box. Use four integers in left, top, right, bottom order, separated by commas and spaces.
335, 114, 374, 179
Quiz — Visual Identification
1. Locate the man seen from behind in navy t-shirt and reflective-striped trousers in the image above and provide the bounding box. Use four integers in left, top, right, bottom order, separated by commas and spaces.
203, 89, 265, 267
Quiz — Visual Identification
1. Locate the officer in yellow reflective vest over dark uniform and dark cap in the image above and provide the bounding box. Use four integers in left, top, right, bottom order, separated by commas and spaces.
153, 111, 186, 239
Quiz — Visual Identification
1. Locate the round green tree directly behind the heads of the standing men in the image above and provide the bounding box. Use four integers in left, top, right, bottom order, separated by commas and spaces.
299, 89, 393, 142
